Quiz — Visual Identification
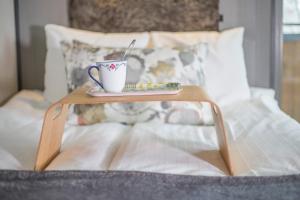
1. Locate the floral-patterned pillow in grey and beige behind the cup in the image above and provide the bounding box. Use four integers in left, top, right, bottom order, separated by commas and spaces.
62, 41, 207, 125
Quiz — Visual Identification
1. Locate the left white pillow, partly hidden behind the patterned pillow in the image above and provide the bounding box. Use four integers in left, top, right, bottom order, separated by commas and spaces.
44, 24, 149, 102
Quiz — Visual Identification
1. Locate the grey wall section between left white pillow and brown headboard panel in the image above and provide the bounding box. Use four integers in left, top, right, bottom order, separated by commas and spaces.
18, 0, 68, 89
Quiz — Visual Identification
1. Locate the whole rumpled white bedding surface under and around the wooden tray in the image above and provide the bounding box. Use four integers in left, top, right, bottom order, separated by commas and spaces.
0, 89, 300, 176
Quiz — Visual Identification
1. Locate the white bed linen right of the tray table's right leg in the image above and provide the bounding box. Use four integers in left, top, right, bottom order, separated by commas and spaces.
222, 97, 300, 175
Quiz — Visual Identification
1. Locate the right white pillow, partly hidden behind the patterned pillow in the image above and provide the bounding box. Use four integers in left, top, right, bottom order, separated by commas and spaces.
151, 28, 250, 105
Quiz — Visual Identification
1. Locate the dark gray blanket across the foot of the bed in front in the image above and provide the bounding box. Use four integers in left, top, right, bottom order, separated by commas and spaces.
0, 171, 300, 200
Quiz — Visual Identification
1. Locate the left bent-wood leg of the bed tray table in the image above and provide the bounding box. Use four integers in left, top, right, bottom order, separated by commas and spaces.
34, 103, 68, 171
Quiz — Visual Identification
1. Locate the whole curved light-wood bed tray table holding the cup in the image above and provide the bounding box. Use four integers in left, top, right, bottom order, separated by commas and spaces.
34, 86, 233, 175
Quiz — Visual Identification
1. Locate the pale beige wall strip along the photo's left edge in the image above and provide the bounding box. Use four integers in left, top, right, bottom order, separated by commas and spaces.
0, 0, 18, 104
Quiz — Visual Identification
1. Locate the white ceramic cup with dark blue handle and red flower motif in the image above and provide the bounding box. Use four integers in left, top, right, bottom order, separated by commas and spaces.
88, 60, 127, 92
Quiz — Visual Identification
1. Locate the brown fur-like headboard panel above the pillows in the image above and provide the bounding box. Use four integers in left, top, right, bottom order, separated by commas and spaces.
69, 0, 220, 32
